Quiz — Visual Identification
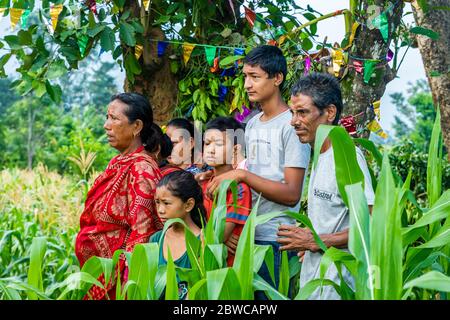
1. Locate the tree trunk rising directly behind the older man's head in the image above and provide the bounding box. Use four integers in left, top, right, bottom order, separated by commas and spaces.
341, 0, 403, 138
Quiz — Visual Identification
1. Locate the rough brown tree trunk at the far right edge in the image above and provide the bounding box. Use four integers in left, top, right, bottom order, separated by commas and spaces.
412, 0, 450, 160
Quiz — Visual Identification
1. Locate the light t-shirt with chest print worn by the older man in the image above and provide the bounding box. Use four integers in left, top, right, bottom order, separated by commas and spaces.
300, 148, 375, 300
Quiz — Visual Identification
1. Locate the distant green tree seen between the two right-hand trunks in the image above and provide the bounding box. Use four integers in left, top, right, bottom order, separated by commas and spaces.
391, 80, 436, 153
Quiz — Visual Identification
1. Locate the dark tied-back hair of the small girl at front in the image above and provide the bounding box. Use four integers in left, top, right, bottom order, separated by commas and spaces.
156, 170, 206, 228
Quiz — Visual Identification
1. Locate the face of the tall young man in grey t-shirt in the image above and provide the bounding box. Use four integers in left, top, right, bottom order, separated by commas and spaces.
242, 64, 283, 102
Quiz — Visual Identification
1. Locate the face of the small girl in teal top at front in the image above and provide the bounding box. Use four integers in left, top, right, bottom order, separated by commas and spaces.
155, 186, 192, 223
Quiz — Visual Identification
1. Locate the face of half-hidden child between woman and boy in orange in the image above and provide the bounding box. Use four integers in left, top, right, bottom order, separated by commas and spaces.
166, 126, 194, 166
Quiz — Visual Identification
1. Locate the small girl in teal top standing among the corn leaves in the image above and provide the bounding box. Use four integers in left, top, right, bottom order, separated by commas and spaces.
150, 170, 205, 300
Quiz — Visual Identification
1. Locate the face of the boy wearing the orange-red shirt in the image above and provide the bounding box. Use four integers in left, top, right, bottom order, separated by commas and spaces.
203, 129, 233, 167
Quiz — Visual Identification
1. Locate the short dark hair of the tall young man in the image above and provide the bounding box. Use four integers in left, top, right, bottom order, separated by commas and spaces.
244, 45, 287, 88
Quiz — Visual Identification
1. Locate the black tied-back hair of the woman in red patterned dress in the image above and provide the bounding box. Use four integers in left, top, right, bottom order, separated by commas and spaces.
110, 92, 159, 152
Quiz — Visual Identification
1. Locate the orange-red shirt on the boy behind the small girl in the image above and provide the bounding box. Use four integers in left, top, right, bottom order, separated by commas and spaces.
201, 177, 252, 267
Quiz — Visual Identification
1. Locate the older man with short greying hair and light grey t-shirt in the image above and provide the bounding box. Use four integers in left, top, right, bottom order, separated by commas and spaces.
277, 73, 374, 300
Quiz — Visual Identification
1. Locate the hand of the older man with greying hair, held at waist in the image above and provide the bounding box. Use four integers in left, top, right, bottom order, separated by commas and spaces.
277, 225, 320, 252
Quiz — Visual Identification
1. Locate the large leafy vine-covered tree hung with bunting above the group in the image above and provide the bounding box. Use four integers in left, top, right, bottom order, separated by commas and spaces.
0, 0, 432, 136
